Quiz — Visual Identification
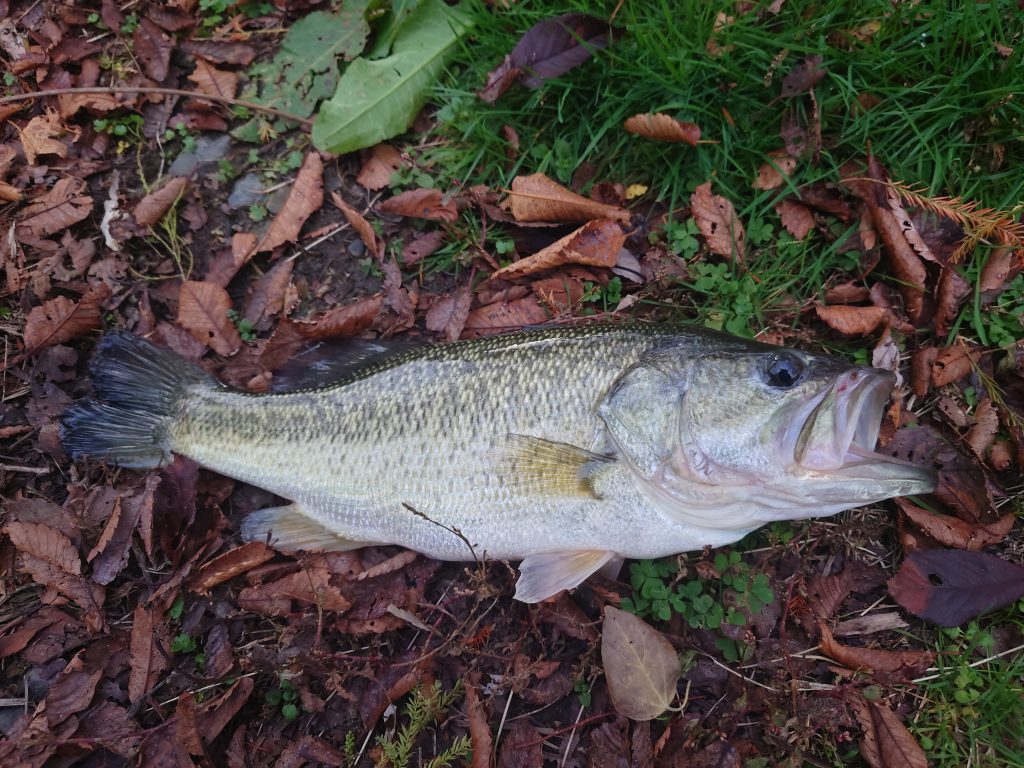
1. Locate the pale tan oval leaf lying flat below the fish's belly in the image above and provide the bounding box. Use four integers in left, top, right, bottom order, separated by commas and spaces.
601, 605, 682, 720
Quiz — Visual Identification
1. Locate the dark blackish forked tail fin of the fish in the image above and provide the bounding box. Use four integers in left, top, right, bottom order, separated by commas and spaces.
60, 331, 218, 469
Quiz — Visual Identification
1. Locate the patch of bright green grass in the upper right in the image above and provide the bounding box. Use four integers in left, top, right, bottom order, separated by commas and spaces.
417, 0, 1024, 340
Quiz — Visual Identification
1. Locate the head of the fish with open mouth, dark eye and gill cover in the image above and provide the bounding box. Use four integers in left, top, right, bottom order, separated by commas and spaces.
606, 345, 936, 529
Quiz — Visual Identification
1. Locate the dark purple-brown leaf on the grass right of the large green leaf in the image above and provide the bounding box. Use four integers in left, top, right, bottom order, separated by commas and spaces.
509, 13, 613, 88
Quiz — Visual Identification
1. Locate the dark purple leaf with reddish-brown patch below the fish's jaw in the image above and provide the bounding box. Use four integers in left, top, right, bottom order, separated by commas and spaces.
889, 549, 1024, 627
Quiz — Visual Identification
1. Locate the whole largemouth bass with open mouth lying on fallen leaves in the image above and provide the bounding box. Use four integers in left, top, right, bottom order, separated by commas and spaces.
60, 323, 936, 602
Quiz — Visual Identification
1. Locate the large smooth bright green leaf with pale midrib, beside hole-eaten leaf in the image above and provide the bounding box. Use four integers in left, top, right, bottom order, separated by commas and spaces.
313, 0, 471, 155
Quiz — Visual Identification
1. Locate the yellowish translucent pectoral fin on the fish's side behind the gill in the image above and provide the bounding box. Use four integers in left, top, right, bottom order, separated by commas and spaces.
504, 433, 615, 498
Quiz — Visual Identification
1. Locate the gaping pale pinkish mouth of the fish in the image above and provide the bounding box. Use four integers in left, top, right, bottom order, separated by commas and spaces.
785, 368, 935, 493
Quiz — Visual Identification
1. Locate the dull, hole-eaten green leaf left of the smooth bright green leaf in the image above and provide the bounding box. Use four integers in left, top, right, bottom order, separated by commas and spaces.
232, 0, 370, 142
